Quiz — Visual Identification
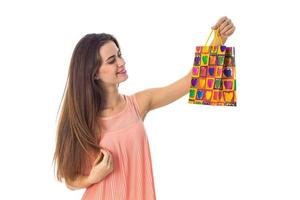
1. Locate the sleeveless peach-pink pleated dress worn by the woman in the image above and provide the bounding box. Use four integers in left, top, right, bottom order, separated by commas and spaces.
82, 95, 156, 200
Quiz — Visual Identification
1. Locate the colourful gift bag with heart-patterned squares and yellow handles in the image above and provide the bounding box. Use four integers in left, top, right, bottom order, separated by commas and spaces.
189, 30, 236, 106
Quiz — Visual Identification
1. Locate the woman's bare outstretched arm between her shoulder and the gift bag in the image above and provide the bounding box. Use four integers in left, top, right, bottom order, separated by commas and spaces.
135, 69, 191, 119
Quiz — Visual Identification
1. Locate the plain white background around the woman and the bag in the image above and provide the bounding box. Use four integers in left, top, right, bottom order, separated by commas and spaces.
0, 0, 300, 200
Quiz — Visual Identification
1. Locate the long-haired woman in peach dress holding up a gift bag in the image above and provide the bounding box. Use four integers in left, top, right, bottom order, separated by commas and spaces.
54, 17, 235, 200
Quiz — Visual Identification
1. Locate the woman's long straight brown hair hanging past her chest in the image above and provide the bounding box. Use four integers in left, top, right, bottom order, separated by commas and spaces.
53, 33, 120, 182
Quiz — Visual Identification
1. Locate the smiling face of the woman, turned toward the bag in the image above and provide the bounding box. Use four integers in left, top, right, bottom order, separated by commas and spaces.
96, 41, 128, 85
